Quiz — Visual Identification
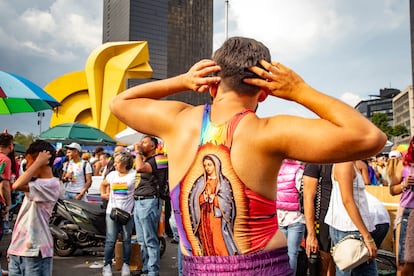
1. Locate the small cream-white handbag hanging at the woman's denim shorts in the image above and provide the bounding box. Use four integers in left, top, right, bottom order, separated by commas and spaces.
331, 235, 369, 270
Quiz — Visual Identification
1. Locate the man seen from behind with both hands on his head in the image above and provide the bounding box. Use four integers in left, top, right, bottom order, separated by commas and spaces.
110, 37, 386, 275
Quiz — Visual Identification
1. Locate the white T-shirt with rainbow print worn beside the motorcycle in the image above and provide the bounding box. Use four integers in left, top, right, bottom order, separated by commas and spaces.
105, 169, 136, 214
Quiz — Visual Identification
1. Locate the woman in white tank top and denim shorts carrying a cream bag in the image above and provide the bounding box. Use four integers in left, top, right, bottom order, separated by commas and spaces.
325, 161, 377, 276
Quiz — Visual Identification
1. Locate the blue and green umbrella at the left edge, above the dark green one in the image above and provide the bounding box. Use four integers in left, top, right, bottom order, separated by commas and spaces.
0, 71, 60, 114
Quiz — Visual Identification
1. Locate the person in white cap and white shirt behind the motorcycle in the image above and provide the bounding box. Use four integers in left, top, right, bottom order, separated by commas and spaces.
63, 143, 92, 201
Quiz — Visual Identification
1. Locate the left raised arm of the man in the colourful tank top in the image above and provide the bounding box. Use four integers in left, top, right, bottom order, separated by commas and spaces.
110, 60, 220, 138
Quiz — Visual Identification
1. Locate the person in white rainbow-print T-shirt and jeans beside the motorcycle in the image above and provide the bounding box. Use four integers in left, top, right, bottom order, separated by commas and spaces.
101, 152, 136, 276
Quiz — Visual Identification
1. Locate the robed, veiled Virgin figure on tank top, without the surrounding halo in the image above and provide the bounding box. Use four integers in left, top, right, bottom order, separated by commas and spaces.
189, 154, 238, 256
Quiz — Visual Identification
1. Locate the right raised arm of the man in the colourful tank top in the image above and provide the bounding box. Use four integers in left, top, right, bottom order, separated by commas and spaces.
244, 61, 387, 163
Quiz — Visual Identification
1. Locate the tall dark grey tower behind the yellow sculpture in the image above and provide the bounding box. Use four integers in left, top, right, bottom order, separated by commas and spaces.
103, 0, 213, 105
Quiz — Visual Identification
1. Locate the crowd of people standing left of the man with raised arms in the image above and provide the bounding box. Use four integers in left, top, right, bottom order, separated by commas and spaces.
0, 133, 173, 276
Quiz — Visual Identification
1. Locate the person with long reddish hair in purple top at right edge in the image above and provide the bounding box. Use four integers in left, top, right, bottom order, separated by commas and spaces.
389, 140, 414, 276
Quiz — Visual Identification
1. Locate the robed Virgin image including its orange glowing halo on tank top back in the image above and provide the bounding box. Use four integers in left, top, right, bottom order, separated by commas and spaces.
180, 143, 258, 256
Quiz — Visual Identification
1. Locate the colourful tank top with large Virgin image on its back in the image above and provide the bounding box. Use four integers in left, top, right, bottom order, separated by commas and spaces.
171, 105, 278, 256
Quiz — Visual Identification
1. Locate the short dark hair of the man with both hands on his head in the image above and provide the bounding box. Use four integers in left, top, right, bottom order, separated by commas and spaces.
213, 37, 271, 94
